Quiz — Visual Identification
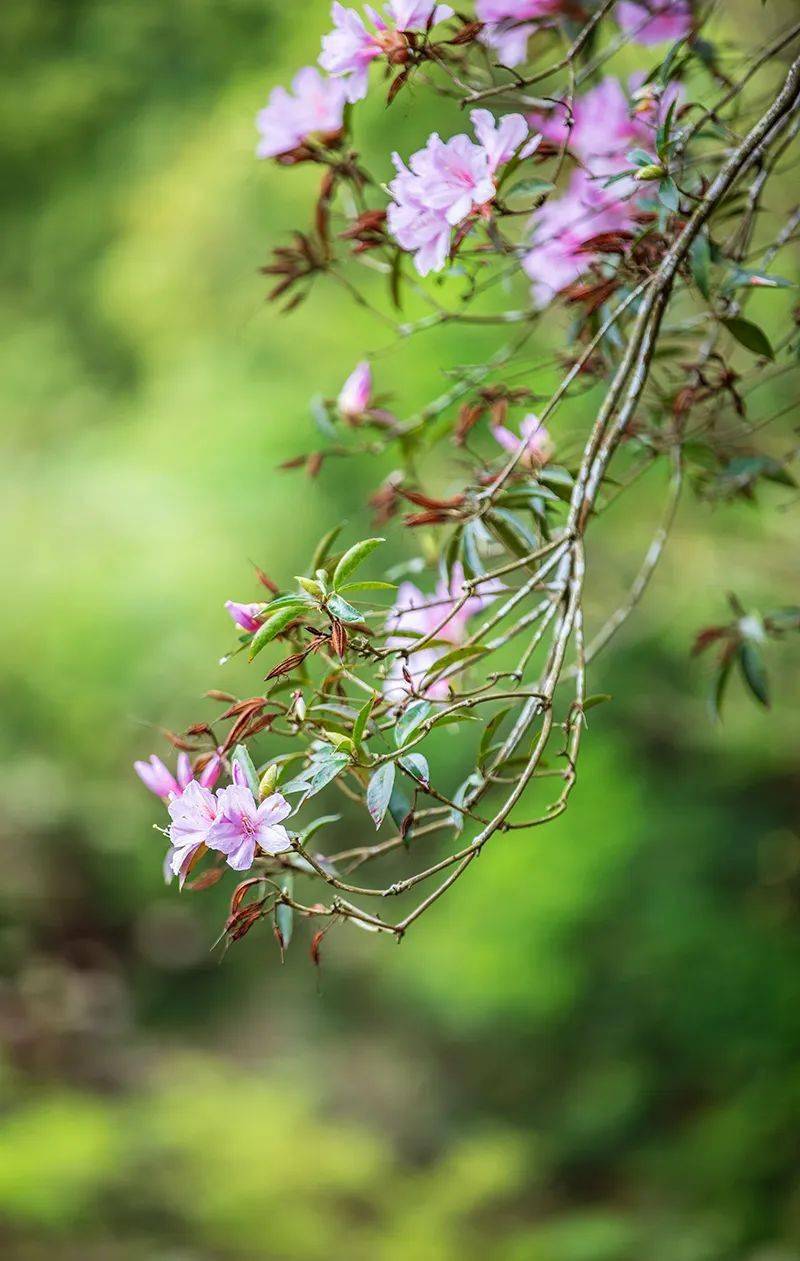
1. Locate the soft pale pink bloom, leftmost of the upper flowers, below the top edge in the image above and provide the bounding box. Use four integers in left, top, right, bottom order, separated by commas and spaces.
256, 66, 346, 158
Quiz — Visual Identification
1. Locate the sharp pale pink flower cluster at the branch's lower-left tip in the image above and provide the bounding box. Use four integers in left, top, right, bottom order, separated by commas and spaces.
134, 753, 291, 888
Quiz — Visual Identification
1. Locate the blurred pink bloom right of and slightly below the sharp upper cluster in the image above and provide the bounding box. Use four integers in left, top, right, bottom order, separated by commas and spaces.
522, 171, 631, 306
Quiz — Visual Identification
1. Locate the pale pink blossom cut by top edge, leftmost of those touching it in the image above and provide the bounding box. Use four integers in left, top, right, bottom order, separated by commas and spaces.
319, 0, 453, 101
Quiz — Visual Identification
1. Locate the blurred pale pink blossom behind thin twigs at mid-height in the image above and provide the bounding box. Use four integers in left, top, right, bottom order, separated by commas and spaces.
384, 565, 502, 700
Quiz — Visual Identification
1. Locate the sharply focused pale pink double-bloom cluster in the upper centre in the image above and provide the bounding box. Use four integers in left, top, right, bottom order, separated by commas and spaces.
386, 110, 539, 276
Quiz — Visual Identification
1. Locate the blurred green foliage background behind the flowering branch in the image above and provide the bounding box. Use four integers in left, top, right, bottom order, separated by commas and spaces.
0, 0, 800, 1261
